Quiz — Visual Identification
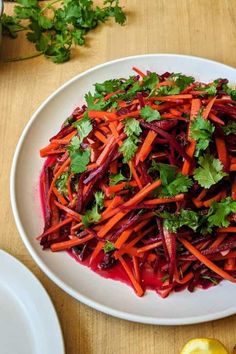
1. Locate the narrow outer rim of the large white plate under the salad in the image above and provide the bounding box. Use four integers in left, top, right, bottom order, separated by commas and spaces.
10, 53, 236, 326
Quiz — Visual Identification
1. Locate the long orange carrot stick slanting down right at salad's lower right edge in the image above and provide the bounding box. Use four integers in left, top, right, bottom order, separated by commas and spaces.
180, 239, 236, 283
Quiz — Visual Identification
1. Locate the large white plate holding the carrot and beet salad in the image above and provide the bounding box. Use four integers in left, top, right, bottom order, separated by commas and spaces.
11, 54, 236, 325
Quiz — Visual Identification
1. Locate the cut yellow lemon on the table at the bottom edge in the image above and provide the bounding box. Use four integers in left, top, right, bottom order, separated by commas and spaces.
180, 338, 229, 354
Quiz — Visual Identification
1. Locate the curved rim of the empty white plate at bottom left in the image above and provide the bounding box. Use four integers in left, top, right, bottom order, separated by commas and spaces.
0, 249, 65, 354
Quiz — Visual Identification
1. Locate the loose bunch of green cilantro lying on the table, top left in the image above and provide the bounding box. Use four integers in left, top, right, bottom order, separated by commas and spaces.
1, 0, 126, 63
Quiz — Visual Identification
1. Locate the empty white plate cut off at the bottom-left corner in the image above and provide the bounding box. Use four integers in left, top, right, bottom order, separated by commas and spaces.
0, 250, 65, 354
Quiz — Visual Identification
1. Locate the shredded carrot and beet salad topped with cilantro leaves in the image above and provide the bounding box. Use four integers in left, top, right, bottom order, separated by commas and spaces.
38, 68, 236, 298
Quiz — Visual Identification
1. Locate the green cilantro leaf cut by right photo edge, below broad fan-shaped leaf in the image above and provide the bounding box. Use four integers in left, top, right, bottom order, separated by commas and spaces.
206, 197, 236, 232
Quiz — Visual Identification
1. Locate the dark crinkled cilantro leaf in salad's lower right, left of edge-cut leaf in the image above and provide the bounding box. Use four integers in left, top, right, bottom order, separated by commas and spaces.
159, 209, 199, 233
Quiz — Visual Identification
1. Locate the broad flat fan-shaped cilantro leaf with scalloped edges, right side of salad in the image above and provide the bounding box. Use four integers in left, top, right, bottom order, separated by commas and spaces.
194, 154, 227, 189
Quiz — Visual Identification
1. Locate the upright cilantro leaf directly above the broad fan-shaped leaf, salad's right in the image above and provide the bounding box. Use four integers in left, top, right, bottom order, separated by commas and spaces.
190, 114, 215, 157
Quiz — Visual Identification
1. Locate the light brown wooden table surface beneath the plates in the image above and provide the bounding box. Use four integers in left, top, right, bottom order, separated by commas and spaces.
0, 0, 236, 354
